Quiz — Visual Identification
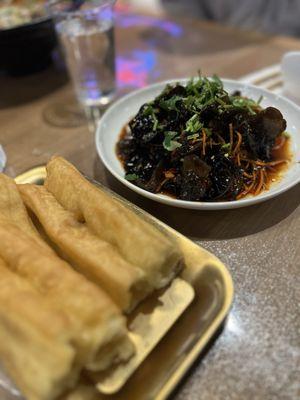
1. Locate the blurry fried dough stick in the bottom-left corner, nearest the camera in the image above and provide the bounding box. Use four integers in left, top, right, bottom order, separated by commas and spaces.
0, 259, 79, 400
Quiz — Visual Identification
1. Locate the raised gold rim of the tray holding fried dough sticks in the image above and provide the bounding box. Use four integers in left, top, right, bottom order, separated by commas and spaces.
15, 166, 234, 400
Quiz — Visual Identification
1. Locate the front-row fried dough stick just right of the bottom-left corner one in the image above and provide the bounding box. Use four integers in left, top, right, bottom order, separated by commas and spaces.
0, 221, 133, 370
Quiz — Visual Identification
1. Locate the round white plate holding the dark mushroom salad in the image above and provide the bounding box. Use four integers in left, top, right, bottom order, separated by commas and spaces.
96, 79, 300, 210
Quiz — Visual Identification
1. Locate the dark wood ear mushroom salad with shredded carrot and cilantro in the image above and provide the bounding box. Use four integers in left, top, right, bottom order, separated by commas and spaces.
117, 76, 290, 201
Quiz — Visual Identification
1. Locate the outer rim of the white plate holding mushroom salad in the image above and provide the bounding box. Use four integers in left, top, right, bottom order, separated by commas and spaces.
95, 77, 300, 210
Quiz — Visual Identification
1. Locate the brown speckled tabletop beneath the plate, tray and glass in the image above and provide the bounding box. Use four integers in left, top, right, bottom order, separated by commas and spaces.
0, 8, 300, 400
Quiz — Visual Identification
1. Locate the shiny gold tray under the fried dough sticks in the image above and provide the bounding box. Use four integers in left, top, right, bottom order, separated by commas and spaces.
16, 167, 233, 400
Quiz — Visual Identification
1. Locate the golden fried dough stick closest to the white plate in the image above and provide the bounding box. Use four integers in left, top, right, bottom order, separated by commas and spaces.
45, 157, 182, 288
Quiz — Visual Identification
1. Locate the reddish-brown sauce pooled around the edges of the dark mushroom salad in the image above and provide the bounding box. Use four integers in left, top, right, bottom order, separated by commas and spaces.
116, 124, 292, 199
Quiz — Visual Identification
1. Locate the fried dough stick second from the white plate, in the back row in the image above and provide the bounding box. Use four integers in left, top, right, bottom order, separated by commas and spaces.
18, 184, 150, 311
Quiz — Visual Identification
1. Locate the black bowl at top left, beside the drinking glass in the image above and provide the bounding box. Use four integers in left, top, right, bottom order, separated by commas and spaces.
0, 17, 57, 76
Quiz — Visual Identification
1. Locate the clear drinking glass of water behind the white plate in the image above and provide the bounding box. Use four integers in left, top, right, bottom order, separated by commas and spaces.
47, 0, 116, 108
